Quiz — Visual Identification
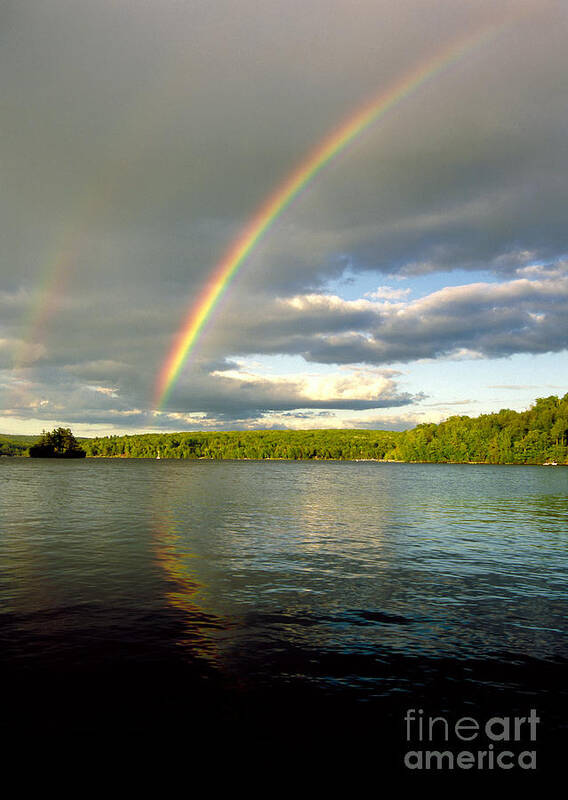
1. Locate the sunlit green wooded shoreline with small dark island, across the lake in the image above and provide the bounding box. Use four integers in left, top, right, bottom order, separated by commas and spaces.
0, 394, 568, 464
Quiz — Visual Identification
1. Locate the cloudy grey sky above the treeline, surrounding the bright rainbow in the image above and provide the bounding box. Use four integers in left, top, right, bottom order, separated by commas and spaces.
0, 0, 568, 436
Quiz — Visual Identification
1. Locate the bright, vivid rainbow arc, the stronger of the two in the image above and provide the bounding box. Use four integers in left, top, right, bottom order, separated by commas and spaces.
154, 23, 503, 411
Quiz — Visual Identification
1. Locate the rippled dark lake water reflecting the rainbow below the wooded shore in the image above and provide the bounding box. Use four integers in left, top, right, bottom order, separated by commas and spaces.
0, 459, 568, 770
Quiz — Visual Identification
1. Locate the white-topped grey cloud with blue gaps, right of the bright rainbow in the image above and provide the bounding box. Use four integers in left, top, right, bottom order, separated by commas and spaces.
250, 273, 568, 365
